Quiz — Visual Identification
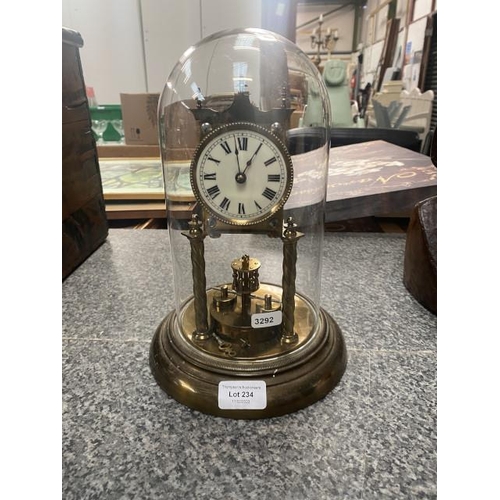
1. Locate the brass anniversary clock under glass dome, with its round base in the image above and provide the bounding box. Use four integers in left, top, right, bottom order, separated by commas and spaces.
150, 29, 347, 419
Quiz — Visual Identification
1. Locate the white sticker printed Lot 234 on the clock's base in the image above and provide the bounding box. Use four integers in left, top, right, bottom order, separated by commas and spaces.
219, 380, 267, 410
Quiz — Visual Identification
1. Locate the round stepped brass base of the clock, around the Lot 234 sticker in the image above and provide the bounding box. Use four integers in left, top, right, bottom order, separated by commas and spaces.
150, 309, 347, 419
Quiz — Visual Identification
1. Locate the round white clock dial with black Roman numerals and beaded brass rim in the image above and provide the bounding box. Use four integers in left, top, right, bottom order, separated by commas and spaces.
191, 123, 293, 225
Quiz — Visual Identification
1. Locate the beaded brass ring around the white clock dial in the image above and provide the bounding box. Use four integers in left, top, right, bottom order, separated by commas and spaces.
190, 121, 293, 227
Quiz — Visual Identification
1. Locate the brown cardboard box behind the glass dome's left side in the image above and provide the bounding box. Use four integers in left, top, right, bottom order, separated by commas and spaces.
120, 93, 160, 145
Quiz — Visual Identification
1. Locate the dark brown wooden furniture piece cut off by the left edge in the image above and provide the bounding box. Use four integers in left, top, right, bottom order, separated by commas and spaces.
62, 28, 108, 279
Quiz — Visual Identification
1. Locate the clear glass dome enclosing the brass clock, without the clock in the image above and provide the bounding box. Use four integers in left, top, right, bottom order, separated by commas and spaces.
159, 29, 330, 309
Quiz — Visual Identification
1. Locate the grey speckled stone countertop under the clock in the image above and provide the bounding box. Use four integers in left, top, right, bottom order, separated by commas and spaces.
62, 229, 437, 500
